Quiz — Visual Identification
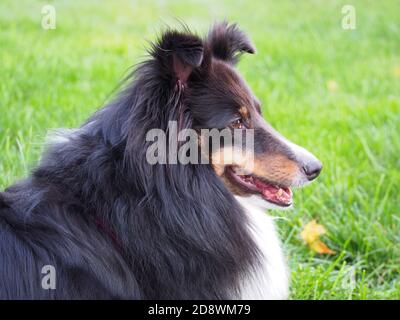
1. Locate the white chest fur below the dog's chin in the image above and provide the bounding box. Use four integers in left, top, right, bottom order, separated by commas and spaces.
236, 196, 289, 300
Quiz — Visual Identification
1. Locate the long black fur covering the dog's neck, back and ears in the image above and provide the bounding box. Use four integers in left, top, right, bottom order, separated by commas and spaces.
0, 25, 257, 299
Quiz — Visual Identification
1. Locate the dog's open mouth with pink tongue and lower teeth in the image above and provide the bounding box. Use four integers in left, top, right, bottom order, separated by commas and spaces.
226, 167, 293, 207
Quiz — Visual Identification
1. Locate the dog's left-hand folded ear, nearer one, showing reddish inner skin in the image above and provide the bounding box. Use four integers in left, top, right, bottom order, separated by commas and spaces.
152, 31, 204, 85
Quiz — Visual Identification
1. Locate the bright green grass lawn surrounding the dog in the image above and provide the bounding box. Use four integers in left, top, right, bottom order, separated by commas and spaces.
0, 0, 400, 299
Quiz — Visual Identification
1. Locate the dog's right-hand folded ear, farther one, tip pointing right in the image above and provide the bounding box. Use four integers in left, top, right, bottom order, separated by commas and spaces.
207, 21, 256, 64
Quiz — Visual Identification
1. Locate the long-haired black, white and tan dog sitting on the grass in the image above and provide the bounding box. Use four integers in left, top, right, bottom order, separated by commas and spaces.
0, 22, 322, 299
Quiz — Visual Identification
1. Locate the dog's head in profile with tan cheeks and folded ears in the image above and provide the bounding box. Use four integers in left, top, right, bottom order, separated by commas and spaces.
148, 23, 322, 208
